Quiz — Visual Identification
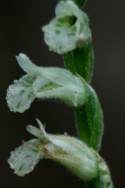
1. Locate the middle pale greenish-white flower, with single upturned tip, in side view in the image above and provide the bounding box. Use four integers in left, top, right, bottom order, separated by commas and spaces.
6, 54, 87, 112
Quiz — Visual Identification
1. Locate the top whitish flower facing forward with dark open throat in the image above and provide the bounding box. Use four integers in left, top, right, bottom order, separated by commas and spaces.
43, 0, 91, 54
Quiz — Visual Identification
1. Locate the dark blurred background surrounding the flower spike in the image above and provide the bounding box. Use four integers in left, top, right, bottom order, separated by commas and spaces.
0, 0, 125, 188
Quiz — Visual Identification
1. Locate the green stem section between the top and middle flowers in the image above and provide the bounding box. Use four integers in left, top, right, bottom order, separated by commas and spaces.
64, 44, 94, 82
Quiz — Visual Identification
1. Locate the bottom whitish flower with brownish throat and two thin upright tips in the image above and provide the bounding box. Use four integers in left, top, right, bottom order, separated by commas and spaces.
8, 120, 97, 181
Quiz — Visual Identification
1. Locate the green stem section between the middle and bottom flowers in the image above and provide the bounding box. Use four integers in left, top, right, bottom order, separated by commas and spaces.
74, 85, 103, 151
